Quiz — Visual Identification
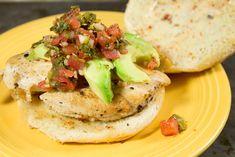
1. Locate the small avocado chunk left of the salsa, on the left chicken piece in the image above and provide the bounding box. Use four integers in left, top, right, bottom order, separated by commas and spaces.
26, 43, 49, 60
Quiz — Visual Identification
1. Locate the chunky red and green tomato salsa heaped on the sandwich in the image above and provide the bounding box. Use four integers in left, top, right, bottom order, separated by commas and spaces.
29, 6, 157, 91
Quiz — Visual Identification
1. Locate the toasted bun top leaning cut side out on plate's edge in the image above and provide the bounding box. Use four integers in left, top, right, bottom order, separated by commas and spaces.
125, 0, 235, 73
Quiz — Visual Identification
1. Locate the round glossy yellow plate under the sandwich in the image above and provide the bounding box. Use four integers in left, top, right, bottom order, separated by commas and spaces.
0, 12, 231, 157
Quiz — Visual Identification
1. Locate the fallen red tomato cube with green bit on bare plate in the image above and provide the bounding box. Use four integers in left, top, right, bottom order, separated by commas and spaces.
160, 114, 187, 136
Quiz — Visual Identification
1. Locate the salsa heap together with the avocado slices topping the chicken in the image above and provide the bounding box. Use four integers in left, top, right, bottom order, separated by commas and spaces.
26, 6, 160, 102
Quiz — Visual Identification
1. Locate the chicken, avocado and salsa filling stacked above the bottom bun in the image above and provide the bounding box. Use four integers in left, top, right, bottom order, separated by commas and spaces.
3, 7, 170, 122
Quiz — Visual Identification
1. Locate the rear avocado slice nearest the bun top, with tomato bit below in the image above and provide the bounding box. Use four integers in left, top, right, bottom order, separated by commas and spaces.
124, 33, 160, 66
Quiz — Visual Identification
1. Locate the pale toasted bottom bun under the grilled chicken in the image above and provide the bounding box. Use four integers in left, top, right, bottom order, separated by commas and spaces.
18, 87, 165, 143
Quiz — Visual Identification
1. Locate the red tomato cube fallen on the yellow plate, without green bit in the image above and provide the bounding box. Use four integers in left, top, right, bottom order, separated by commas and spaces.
160, 118, 179, 136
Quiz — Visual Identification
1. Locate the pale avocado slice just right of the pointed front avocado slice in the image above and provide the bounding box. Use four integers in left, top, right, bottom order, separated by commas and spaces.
113, 53, 150, 83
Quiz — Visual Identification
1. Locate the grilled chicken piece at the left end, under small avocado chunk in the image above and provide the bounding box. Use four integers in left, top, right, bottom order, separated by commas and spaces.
3, 54, 52, 101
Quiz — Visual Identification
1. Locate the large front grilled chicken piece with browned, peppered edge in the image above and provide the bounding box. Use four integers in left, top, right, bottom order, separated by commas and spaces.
40, 71, 170, 121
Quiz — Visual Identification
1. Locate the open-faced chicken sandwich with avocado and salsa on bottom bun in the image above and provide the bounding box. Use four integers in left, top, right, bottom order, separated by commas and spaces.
3, 7, 170, 143
